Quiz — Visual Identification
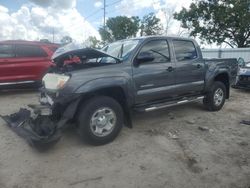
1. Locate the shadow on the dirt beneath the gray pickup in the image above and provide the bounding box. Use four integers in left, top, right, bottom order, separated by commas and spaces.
57, 102, 207, 151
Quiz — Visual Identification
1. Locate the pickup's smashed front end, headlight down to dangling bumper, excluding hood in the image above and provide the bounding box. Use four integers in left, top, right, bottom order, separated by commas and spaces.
1, 70, 72, 147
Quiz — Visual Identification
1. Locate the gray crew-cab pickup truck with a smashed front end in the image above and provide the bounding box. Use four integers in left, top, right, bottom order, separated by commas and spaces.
2, 36, 238, 145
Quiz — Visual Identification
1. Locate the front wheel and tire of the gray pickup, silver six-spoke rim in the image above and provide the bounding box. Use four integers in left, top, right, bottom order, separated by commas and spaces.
77, 96, 124, 145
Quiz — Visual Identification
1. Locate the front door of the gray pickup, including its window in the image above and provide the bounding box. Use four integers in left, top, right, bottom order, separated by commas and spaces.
133, 40, 175, 104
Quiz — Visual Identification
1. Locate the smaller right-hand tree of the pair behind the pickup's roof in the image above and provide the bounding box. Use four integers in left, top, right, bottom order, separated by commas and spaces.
140, 13, 162, 36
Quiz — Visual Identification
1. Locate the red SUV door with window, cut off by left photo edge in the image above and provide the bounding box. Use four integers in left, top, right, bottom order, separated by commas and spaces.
0, 43, 15, 85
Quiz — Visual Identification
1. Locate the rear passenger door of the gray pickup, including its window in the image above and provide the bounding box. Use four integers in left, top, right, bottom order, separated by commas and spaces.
172, 40, 205, 95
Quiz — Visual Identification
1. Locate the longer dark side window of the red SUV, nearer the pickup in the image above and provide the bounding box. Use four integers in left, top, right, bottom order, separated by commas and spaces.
16, 44, 48, 57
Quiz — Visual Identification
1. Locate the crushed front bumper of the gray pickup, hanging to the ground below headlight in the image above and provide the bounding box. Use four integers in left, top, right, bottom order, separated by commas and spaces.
1, 91, 80, 147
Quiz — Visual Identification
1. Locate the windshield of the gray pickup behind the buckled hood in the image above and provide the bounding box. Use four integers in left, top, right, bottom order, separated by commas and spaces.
101, 40, 139, 63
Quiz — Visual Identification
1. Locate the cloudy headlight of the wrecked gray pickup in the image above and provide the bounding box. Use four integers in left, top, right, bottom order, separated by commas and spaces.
43, 73, 70, 91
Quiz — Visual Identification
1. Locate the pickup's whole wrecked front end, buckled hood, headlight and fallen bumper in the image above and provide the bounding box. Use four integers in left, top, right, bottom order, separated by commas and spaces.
1, 43, 119, 146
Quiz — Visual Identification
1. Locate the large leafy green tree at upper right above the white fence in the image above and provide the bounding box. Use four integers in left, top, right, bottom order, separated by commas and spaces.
174, 0, 250, 48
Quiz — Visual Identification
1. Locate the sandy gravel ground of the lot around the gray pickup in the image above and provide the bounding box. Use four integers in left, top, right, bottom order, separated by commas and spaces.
0, 90, 250, 188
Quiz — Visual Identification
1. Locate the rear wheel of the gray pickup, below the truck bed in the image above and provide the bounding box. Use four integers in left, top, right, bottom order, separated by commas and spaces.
203, 81, 226, 111
